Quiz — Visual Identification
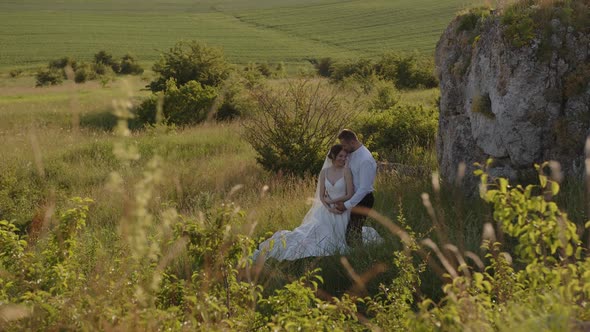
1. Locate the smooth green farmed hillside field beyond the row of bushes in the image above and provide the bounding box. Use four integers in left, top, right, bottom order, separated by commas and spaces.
0, 0, 479, 68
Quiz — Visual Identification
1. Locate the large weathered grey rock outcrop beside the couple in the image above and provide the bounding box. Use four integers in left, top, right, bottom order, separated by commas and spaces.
436, 7, 590, 188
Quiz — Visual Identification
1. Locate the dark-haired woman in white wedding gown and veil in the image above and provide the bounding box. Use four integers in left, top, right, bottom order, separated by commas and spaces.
253, 144, 382, 260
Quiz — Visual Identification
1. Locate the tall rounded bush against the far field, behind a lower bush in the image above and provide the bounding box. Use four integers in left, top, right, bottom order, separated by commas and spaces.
148, 41, 230, 92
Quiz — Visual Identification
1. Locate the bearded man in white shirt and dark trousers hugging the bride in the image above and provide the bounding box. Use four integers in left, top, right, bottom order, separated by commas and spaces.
336, 129, 377, 247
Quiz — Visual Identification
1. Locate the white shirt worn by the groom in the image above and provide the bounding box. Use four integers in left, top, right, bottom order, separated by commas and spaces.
344, 145, 377, 209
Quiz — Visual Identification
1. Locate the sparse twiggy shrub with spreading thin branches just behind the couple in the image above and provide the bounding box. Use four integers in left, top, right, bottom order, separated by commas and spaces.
245, 81, 352, 176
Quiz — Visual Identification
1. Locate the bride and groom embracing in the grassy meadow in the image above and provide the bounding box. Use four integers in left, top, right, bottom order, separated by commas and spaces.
254, 129, 382, 260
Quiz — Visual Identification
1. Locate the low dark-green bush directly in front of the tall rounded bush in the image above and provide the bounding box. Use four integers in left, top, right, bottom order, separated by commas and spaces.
136, 79, 217, 125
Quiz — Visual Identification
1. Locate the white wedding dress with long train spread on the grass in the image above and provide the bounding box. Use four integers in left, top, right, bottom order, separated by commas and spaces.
253, 177, 383, 261
